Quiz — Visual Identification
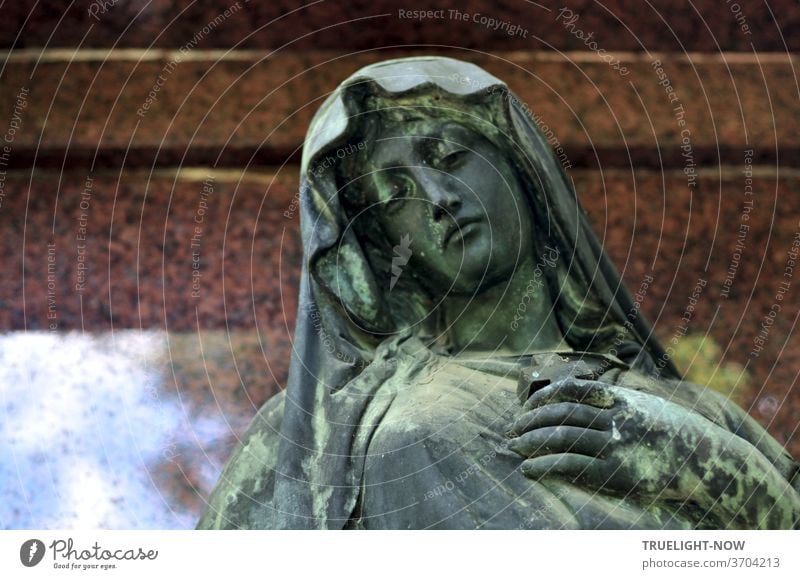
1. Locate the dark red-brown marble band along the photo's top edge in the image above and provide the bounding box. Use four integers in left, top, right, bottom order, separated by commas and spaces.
0, 0, 800, 52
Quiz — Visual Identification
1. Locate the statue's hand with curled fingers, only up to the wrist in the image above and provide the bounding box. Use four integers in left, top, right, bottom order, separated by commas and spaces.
509, 378, 679, 494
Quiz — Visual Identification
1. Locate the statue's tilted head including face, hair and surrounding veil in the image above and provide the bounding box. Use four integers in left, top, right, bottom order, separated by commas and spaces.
302, 57, 680, 376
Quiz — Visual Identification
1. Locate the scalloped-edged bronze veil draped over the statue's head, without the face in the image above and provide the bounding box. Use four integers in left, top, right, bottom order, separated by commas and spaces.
200, 57, 678, 528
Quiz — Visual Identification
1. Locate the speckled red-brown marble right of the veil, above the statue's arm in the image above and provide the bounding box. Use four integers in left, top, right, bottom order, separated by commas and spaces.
574, 166, 800, 456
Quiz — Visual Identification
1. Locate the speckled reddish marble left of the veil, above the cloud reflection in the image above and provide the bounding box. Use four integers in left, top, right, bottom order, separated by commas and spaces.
0, 167, 301, 331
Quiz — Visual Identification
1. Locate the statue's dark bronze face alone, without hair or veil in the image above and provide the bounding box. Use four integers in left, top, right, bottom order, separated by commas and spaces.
362, 120, 532, 294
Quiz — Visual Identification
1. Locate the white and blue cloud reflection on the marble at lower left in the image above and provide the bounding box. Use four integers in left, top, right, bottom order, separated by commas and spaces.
0, 330, 231, 529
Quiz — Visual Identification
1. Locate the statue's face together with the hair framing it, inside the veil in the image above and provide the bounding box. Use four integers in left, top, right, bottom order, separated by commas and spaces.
339, 101, 532, 299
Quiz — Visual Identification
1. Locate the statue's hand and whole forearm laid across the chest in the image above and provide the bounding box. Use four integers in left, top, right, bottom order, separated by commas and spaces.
509, 378, 800, 528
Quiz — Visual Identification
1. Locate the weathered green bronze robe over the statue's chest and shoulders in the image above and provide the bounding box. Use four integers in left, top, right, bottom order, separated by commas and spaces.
200, 339, 796, 529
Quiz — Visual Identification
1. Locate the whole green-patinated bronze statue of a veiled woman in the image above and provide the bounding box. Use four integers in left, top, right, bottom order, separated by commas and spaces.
199, 57, 800, 529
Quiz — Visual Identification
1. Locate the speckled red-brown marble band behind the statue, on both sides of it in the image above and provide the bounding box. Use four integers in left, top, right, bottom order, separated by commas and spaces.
0, 165, 800, 454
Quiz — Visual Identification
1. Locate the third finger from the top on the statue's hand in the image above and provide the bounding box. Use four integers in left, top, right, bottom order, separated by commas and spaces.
508, 425, 611, 458
